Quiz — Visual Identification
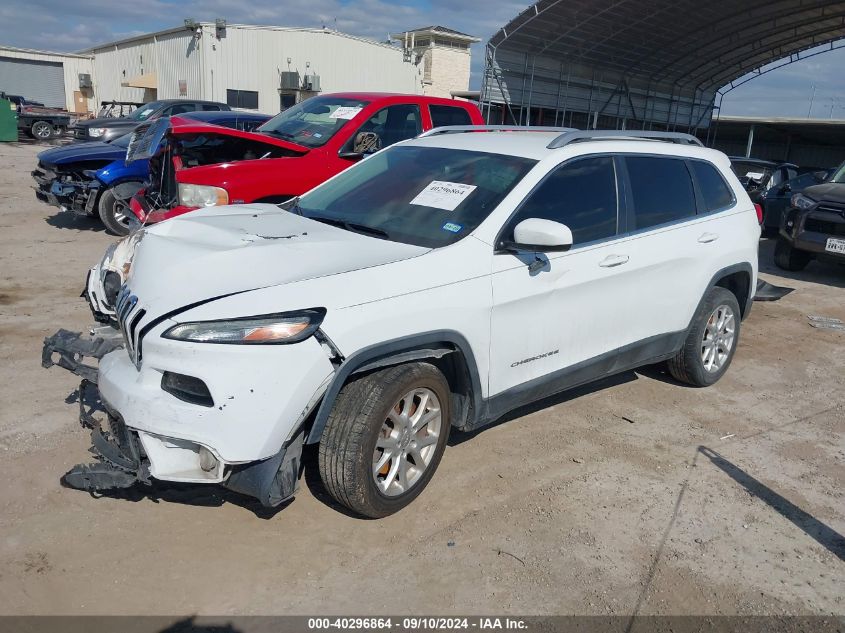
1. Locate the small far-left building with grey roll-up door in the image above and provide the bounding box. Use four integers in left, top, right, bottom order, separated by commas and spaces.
0, 46, 94, 113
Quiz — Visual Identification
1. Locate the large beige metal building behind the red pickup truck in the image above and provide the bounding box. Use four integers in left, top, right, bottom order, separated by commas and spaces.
85, 20, 422, 114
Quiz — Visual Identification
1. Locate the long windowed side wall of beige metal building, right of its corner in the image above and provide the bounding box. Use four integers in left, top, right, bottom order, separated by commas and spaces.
202, 26, 422, 114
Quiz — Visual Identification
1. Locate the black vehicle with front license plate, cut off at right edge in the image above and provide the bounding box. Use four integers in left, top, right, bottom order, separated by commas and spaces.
775, 163, 845, 270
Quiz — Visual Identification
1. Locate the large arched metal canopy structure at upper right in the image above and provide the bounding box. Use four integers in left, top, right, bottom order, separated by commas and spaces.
481, 0, 845, 132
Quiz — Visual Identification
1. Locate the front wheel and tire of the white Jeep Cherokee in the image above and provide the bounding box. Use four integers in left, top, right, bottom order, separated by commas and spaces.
319, 363, 451, 518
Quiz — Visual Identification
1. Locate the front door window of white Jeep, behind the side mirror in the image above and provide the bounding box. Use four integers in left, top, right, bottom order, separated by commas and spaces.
506, 156, 619, 245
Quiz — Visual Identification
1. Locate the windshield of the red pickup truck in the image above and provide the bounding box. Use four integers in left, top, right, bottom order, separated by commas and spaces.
256, 95, 369, 147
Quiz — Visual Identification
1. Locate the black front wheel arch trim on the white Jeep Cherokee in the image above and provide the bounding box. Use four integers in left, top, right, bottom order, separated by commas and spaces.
305, 330, 481, 444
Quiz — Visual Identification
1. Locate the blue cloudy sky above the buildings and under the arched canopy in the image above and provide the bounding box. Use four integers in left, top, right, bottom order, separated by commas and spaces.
0, 0, 845, 118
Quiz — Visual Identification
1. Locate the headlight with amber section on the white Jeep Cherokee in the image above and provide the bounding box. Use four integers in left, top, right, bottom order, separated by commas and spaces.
162, 308, 326, 345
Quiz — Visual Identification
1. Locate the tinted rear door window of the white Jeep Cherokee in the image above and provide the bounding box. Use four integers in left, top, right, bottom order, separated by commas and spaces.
625, 156, 696, 231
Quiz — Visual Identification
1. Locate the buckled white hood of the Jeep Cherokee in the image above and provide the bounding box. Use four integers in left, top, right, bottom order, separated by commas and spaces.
127, 204, 429, 315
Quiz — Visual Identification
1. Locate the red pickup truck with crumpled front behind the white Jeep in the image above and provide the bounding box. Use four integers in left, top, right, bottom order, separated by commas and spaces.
130, 92, 484, 224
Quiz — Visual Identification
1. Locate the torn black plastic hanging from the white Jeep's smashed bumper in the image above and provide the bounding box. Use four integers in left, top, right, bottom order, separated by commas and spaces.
62, 379, 151, 494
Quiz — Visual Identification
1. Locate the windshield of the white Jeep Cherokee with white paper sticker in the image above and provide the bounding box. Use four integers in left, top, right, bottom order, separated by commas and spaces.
290, 146, 537, 248
